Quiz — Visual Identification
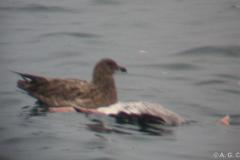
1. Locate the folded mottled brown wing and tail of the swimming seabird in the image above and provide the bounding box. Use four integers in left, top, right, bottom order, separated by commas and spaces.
15, 73, 96, 107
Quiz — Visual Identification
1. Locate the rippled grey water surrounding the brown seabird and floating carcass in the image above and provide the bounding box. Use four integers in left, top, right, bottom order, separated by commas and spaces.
0, 0, 240, 160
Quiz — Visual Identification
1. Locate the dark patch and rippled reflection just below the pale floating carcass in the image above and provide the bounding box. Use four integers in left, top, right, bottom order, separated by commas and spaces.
87, 113, 172, 136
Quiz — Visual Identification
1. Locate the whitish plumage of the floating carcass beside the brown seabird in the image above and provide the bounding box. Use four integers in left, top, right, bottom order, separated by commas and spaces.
75, 101, 186, 126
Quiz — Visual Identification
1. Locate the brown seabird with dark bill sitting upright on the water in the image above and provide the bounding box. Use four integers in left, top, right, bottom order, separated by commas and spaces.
16, 59, 127, 108
